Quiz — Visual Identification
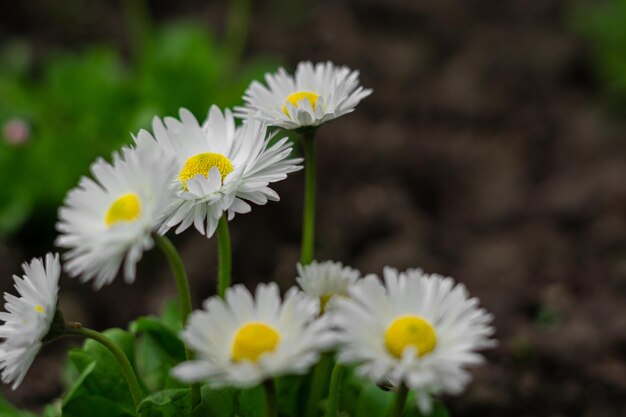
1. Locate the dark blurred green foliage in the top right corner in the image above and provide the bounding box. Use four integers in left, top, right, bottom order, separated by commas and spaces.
570, 0, 626, 110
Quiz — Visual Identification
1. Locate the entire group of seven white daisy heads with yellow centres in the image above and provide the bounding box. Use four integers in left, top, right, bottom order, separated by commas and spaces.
0, 62, 494, 411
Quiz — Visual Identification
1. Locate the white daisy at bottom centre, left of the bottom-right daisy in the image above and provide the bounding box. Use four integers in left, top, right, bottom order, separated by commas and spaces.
173, 283, 332, 388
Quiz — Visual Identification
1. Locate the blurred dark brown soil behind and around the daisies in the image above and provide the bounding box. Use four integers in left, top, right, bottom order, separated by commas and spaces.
0, 0, 626, 417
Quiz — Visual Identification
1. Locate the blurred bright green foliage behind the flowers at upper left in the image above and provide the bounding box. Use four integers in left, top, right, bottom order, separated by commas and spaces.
0, 23, 275, 236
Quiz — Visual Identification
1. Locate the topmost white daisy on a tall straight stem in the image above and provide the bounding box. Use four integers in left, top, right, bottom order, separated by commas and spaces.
235, 62, 372, 129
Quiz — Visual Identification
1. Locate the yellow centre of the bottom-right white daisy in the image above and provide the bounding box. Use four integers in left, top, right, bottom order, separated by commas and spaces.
385, 316, 437, 358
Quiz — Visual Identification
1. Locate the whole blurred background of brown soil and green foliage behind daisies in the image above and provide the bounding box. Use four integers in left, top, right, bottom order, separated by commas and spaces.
0, 0, 626, 417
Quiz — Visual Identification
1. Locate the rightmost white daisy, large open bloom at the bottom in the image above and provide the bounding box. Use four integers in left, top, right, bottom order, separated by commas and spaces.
334, 268, 495, 412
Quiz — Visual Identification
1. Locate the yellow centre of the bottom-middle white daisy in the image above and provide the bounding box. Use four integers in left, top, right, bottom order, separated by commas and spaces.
231, 322, 280, 362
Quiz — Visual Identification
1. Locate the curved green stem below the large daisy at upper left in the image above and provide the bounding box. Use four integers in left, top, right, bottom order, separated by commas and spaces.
153, 233, 200, 410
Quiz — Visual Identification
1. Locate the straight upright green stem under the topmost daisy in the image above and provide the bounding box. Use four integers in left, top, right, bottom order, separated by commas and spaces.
300, 128, 316, 265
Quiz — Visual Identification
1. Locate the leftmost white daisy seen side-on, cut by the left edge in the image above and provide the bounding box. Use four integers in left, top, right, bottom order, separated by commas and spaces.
0, 253, 61, 389
